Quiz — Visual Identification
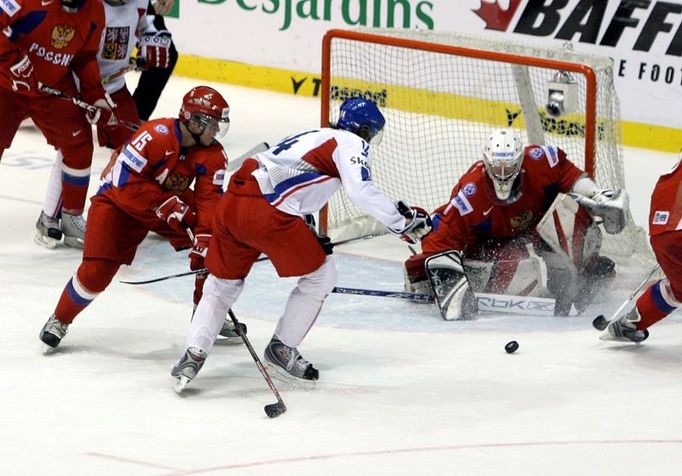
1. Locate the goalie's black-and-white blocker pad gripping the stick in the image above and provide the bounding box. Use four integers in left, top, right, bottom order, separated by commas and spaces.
425, 250, 477, 321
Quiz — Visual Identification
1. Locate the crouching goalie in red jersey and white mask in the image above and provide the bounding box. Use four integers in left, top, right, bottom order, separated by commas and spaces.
405, 129, 628, 319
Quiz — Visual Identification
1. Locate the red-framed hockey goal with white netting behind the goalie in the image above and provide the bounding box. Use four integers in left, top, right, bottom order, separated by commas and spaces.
321, 29, 648, 266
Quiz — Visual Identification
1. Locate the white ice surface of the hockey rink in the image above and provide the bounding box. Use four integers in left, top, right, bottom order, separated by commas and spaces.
0, 78, 682, 476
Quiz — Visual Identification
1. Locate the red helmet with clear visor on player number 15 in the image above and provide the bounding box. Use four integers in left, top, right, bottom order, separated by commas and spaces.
179, 86, 230, 142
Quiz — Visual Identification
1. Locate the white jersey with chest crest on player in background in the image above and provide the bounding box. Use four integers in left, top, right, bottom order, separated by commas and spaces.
97, 0, 155, 94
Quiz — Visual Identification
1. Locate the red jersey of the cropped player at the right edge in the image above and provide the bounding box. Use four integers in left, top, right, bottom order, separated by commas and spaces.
649, 154, 682, 236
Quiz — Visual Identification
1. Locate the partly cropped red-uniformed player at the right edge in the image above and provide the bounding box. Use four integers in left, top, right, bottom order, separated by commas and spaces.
602, 154, 682, 342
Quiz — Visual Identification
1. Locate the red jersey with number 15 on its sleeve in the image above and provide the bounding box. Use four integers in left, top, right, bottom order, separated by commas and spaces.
97, 118, 227, 233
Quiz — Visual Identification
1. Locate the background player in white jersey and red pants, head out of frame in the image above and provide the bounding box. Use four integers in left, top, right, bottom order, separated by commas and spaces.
35, 0, 170, 248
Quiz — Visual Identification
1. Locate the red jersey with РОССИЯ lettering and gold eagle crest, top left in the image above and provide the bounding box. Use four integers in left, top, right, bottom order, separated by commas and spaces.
0, 0, 104, 102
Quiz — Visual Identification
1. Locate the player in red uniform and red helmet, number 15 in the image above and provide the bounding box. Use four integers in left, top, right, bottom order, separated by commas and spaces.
40, 86, 229, 347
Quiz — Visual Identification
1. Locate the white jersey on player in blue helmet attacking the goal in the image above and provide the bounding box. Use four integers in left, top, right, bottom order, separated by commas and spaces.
253, 128, 406, 230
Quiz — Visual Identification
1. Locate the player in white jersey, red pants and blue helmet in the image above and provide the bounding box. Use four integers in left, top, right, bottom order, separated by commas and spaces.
171, 98, 431, 392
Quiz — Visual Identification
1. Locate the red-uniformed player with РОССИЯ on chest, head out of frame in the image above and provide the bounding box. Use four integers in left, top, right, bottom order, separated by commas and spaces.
0, 0, 115, 245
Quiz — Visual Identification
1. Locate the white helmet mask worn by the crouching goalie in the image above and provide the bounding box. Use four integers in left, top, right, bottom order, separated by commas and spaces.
483, 129, 523, 200
